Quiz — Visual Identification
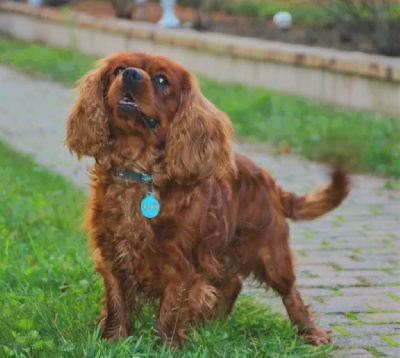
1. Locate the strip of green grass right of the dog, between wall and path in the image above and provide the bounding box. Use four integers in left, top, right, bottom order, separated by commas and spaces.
201, 79, 400, 177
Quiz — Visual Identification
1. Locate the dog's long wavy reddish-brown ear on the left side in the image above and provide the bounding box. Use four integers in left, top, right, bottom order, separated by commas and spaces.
65, 62, 110, 158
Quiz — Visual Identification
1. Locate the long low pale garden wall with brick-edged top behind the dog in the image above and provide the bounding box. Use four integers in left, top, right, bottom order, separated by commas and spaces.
0, 2, 400, 114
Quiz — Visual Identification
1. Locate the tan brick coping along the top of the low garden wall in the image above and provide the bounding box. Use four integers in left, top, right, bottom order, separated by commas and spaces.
0, 2, 400, 83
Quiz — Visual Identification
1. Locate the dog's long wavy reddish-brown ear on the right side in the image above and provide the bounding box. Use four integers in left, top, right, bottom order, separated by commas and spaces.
165, 74, 236, 184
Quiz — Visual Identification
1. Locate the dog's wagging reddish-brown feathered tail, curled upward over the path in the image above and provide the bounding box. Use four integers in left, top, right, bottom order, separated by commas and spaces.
279, 168, 350, 221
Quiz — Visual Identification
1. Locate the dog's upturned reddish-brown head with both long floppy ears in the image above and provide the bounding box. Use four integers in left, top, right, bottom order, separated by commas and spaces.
66, 53, 234, 183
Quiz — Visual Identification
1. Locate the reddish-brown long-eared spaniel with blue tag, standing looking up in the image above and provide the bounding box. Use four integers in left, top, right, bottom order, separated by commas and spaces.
66, 53, 349, 345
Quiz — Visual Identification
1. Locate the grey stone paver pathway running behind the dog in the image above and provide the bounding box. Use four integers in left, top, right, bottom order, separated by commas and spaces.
0, 66, 400, 357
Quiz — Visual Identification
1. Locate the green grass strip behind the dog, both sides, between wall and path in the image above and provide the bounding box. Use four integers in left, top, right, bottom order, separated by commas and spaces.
0, 36, 400, 177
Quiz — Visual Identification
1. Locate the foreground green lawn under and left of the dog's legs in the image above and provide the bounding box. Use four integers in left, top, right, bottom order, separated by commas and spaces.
0, 143, 331, 358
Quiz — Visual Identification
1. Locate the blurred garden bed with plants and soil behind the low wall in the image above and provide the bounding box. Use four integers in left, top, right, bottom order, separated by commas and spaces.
73, 0, 400, 56
